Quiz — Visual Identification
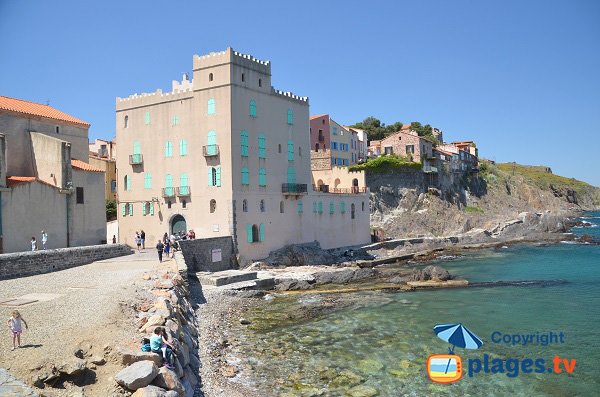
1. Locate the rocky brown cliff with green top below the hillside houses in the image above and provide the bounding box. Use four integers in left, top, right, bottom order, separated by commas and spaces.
367, 162, 600, 238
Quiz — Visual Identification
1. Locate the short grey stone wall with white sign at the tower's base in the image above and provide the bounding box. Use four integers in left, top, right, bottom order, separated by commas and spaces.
179, 236, 236, 272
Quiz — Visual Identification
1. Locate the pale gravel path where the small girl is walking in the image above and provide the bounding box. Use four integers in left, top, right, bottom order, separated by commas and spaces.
0, 249, 166, 396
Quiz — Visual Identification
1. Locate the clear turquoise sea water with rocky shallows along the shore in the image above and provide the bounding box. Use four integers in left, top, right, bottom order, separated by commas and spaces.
240, 213, 600, 396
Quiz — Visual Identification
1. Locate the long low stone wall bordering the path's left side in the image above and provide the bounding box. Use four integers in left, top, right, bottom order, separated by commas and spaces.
0, 244, 133, 280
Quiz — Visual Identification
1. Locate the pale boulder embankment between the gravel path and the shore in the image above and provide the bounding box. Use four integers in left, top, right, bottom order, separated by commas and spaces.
111, 272, 200, 397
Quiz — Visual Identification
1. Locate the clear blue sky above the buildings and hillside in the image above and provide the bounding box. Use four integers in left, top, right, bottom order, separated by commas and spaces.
0, 0, 600, 186
